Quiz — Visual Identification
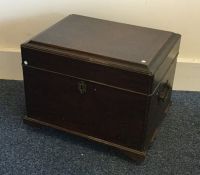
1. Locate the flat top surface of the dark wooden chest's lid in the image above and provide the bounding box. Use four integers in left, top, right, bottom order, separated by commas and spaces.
26, 15, 180, 75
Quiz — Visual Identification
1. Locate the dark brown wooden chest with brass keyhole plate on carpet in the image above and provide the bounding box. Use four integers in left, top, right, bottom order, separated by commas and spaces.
21, 15, 180, 159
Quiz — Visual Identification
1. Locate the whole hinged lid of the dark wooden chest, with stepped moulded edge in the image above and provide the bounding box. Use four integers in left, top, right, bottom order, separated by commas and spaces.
22, 15, 180, 95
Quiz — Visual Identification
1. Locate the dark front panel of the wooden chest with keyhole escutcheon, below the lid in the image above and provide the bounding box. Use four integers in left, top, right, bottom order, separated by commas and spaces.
23, 66, 147, 150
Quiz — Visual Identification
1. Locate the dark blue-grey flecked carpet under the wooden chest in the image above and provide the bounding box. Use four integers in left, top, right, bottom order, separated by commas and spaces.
0, 80, 200, 175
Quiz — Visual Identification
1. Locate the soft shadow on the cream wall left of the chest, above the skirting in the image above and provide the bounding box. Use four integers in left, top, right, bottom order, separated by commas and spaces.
0, 13, 65, 51
